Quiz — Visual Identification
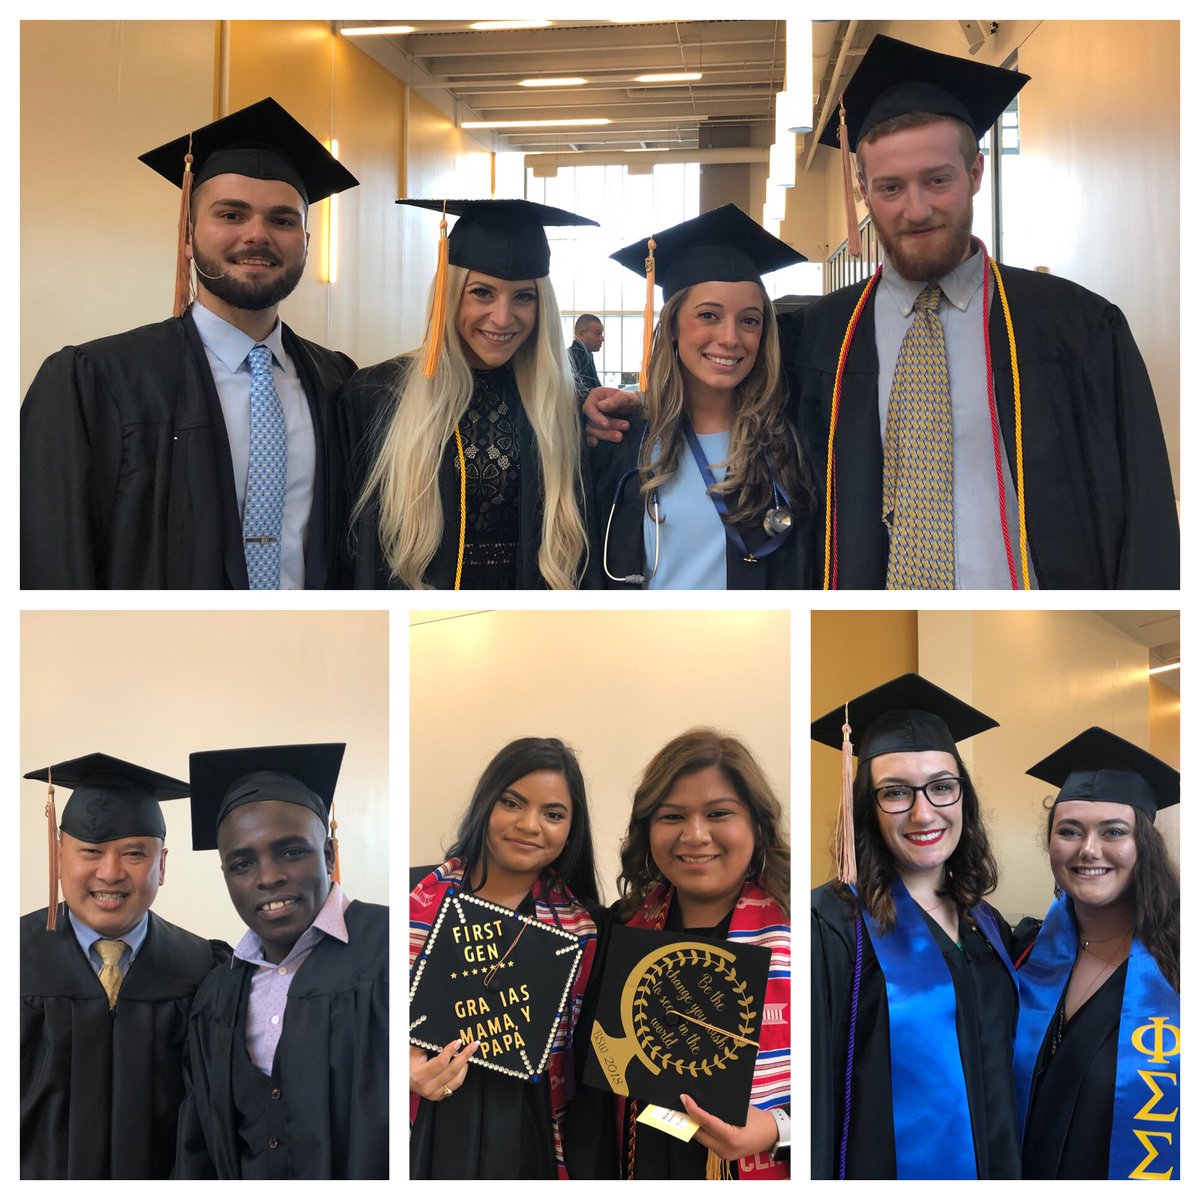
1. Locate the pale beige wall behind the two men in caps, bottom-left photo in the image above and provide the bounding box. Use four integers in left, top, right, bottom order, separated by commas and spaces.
18, 612, 390, 942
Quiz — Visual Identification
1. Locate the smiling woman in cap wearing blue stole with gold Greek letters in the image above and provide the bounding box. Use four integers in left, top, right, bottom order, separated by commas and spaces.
1015, 726, 1180, 1180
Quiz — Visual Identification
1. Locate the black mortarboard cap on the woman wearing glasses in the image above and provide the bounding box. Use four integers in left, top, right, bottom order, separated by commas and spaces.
812, 673, 1000, 762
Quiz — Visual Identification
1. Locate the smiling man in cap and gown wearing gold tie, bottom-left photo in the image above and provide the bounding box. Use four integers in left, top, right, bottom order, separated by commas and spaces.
20, 754, 229, 1180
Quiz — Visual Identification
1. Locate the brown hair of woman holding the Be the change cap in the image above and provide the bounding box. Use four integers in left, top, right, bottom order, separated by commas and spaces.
617, 727, 792, 920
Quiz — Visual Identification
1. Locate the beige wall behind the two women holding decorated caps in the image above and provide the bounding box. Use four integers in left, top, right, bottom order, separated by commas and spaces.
409, 612, 791, 901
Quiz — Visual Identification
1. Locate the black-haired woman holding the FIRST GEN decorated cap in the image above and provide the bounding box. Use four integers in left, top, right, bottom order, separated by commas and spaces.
409, 738, 599, 1180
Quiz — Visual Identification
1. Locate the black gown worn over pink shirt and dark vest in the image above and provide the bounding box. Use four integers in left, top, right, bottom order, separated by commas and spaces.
175, 900, 388, 1180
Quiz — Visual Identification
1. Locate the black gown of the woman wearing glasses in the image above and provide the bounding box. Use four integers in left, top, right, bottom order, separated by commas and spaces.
811, 883, 1020, 1180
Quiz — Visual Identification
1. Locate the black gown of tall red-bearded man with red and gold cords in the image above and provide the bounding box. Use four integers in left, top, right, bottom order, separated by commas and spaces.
780, 266, 1180, 589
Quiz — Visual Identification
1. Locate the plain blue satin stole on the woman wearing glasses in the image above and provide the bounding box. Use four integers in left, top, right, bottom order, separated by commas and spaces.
863, 880, 1016, 1180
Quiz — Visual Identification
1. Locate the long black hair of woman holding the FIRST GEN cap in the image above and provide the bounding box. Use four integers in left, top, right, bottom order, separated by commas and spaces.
449, 738, 600, 905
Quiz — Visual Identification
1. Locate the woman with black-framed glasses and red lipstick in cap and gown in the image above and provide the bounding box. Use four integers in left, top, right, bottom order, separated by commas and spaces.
811, 674, 1021, 1180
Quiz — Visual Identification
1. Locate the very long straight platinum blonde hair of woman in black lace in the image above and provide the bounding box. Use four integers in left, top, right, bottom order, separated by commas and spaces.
354, 266, 587, 589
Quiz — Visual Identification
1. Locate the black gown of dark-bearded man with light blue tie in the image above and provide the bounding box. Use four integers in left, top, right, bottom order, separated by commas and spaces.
20, 313, 354, 588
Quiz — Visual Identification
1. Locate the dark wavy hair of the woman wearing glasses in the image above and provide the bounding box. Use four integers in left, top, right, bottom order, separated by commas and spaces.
852, 750, 1000, 932
